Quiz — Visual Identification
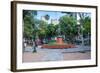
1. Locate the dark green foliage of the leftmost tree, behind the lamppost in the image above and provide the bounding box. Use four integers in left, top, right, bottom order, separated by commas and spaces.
23, 10, 37, 38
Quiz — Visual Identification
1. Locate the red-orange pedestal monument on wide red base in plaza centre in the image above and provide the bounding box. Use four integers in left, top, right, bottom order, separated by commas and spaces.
42, 14, 75, 49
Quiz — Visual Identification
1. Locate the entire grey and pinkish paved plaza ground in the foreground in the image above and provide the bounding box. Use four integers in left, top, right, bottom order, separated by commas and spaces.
23, 46, 91, 62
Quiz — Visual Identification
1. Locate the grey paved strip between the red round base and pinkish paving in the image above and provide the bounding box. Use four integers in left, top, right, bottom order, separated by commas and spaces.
25, 45, 91, 53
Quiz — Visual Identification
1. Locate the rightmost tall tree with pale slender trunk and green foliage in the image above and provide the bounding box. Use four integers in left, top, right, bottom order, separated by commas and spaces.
78, 12, 90, 45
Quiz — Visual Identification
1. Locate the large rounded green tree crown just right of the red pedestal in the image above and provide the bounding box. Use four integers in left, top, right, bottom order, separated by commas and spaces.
59, 15, 77, 42
